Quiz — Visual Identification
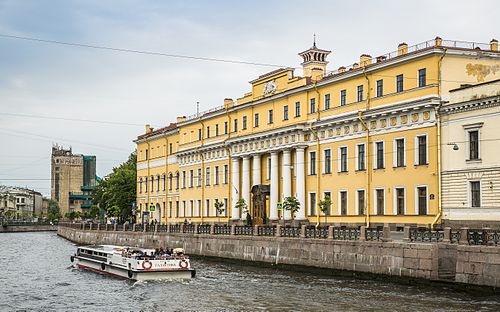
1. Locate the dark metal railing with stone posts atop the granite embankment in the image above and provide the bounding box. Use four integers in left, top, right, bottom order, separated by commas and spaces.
59, 223, 500, 246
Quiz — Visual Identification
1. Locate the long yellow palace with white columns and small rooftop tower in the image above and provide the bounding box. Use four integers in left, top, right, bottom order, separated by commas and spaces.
135, 37, 500, 226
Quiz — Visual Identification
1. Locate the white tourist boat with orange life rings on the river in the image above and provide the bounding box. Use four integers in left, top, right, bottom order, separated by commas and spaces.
70, 245, 196, 281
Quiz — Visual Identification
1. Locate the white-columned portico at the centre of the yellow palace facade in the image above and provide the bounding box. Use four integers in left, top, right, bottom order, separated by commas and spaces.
227, 129, 307, 222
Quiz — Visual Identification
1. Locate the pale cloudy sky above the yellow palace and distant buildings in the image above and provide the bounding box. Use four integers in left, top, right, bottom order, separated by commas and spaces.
0, 0, 500, 196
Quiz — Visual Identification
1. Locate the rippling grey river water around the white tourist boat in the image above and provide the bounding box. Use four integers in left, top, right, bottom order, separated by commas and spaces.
0, 232, 500, 311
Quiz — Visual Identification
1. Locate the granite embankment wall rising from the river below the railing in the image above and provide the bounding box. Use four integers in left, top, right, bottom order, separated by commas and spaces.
58, 226, 500, 287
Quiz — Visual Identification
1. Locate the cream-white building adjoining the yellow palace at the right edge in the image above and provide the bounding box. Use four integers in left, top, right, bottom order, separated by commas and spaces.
441, 79, 500, 228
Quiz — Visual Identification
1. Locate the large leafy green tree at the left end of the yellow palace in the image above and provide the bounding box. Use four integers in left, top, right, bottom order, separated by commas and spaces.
90, 152, 137, 222
